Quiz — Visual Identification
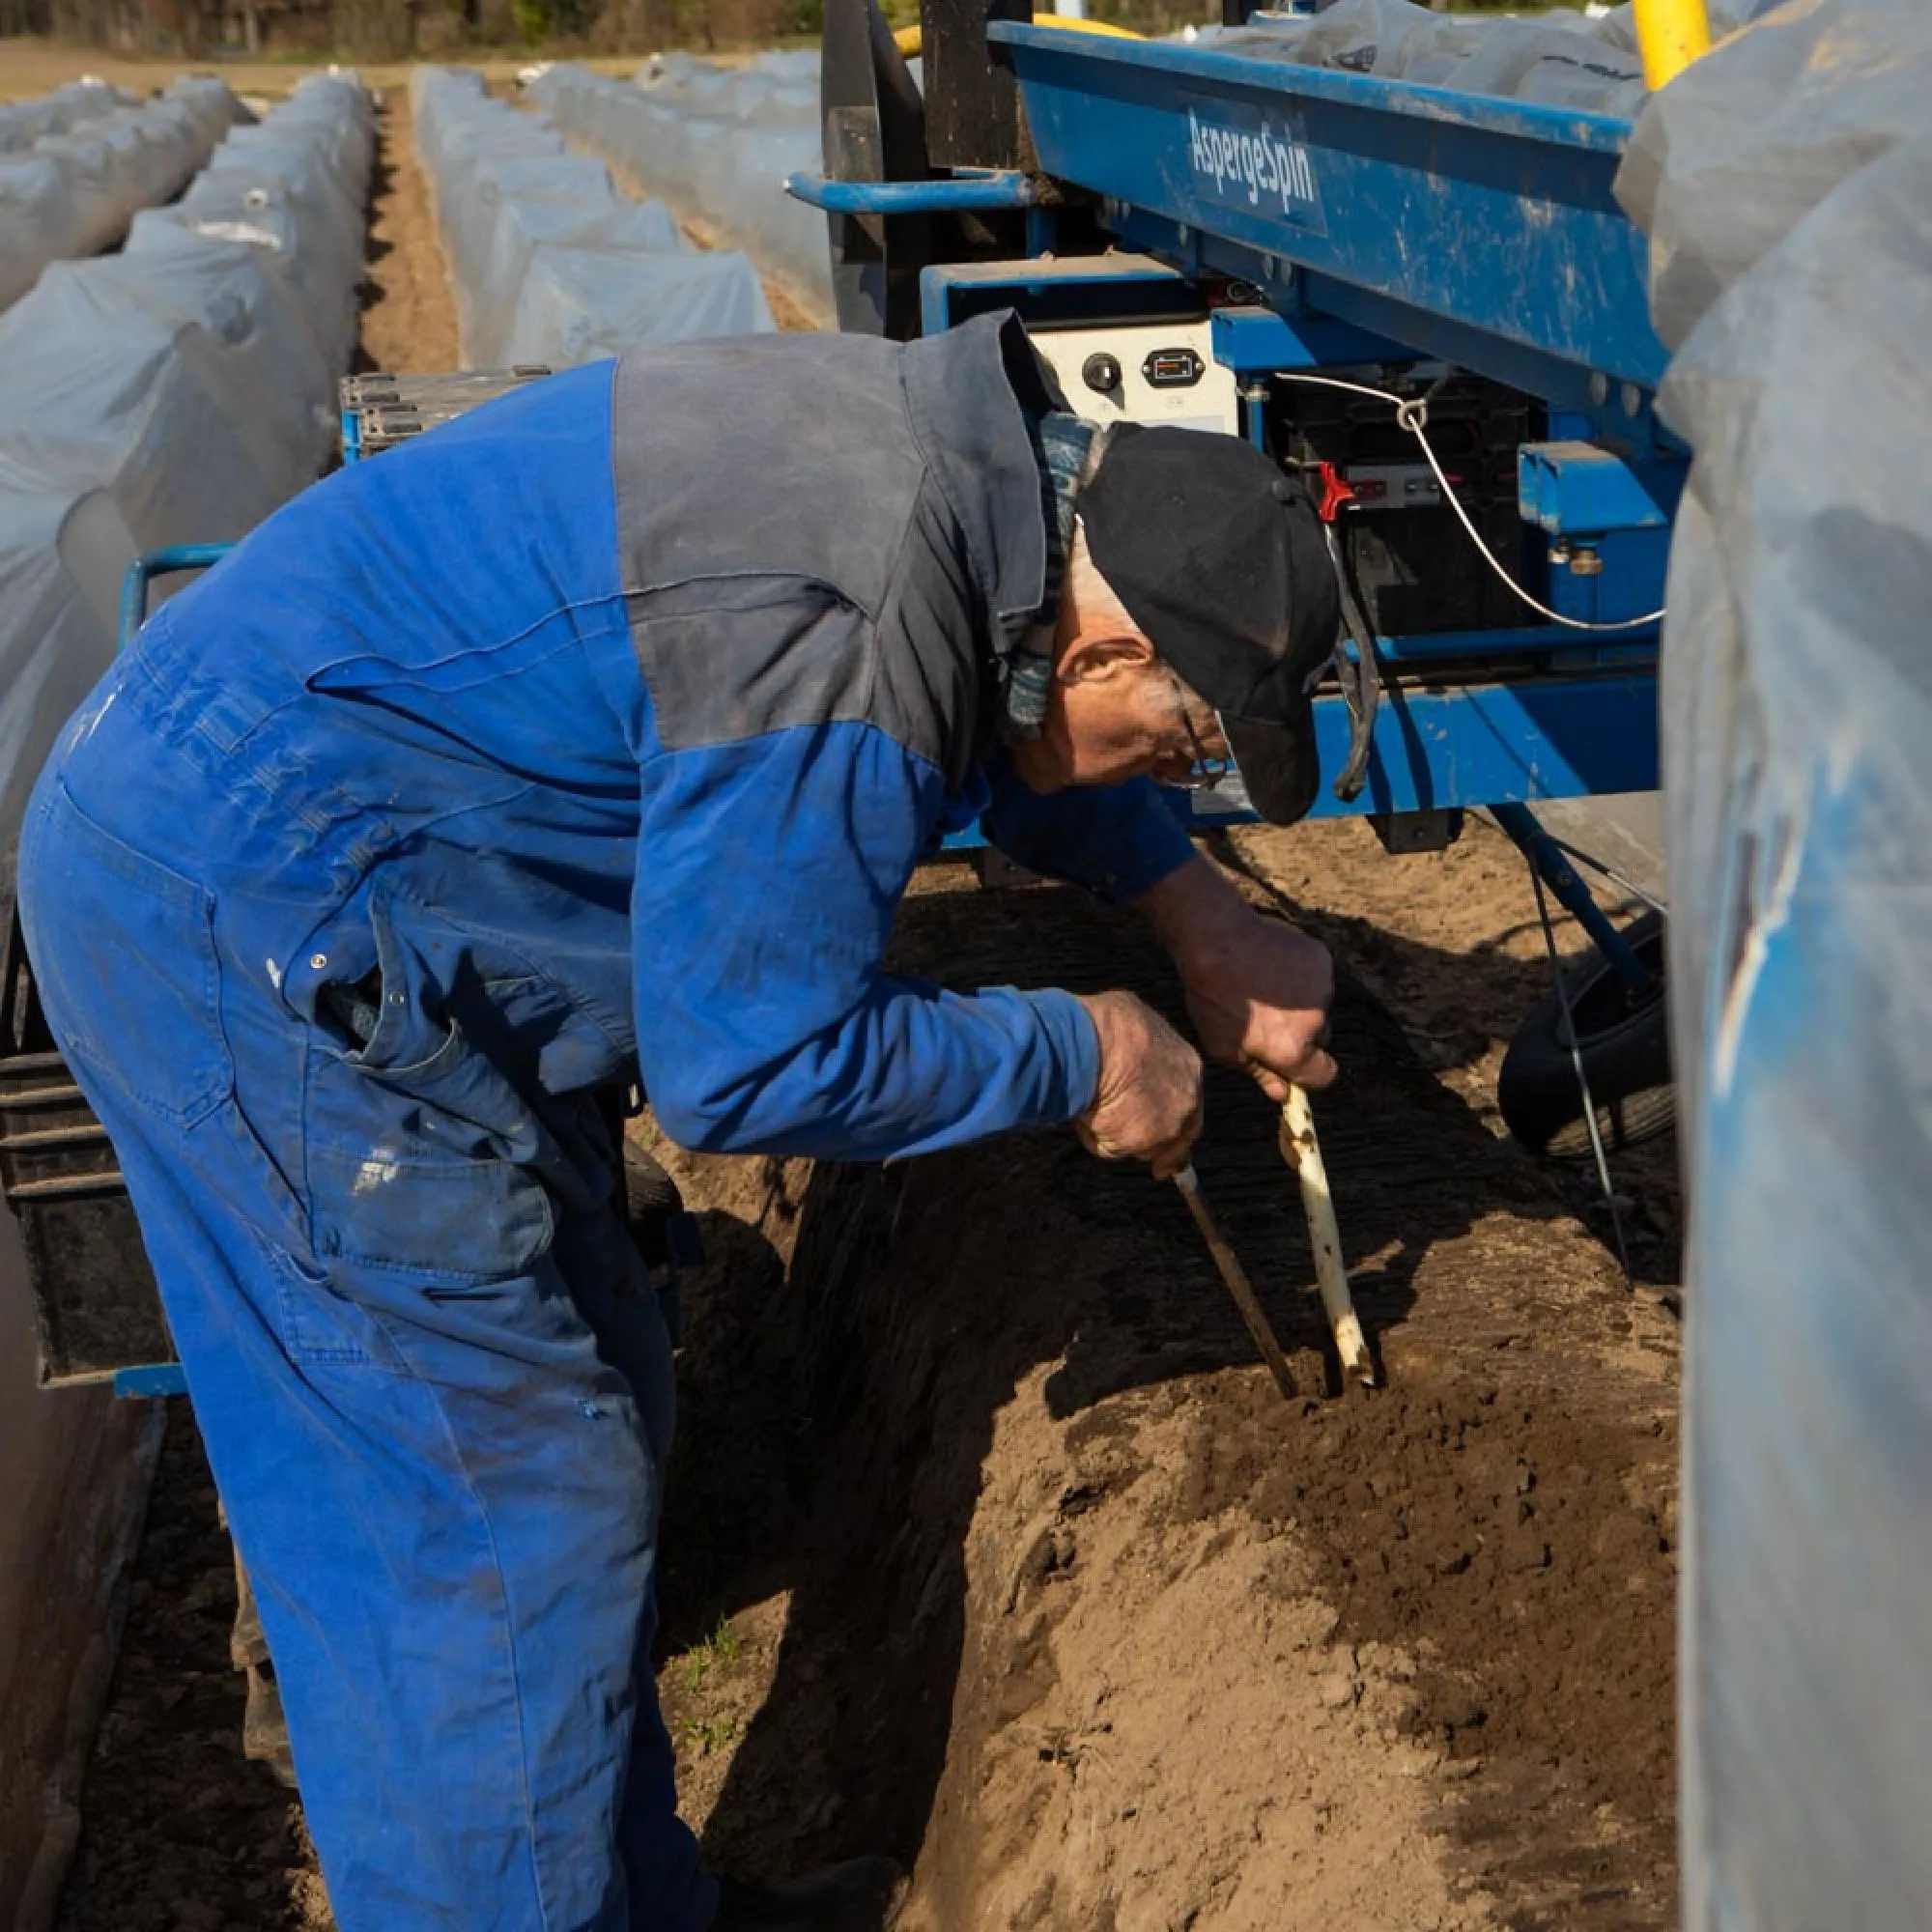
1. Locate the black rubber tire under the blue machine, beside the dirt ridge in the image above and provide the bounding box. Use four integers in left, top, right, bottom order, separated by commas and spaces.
1495, 912, 1677, 1161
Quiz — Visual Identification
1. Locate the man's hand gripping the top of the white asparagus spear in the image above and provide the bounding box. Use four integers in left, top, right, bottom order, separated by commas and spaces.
1179, 908, 1335, 1101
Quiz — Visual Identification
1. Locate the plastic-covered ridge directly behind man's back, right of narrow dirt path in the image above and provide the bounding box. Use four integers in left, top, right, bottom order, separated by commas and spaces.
410, 68, 775, 369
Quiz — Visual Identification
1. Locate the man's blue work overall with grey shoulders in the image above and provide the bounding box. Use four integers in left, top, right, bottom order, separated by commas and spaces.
21, 321, 1188, 1932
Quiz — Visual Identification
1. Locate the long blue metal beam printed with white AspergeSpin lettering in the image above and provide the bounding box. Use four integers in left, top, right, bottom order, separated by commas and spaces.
987, 21, 1667, 427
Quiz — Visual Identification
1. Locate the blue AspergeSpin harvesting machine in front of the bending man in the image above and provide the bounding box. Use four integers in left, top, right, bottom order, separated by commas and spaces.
786, 0, 1689, 1153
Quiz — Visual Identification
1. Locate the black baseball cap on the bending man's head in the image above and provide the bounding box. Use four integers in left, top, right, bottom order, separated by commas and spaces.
1080, 423, 1341, 825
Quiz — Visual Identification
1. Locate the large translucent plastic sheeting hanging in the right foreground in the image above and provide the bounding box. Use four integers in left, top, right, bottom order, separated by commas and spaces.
1619, 0, 1932, 1932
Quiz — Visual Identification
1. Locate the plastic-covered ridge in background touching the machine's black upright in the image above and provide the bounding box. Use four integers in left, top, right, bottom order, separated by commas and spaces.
531, 50, 833, 321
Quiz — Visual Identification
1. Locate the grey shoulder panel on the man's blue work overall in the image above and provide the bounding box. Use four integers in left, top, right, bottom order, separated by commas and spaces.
612, 336, 985, 779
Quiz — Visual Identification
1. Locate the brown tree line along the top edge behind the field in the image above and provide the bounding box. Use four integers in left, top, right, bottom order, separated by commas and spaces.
0, 0, 1511, 60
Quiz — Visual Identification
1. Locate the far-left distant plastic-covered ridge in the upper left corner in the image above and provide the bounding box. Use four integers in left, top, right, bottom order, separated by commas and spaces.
0, 79, 245, 309
